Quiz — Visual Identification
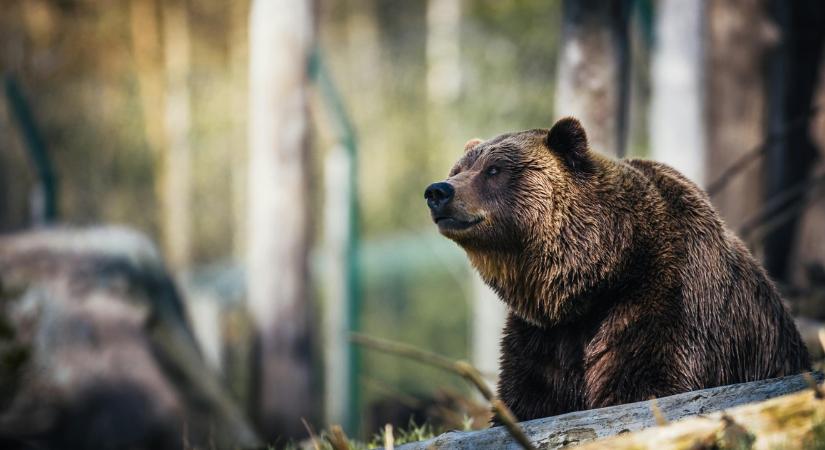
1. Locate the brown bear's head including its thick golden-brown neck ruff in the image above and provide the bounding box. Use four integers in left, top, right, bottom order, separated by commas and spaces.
424, 118, 630, 325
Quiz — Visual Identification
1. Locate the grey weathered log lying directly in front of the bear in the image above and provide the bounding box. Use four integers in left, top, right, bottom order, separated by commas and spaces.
397, 373, 823, 450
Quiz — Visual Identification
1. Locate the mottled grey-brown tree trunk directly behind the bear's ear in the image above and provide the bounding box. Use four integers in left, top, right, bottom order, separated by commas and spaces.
555, 0, 631, 156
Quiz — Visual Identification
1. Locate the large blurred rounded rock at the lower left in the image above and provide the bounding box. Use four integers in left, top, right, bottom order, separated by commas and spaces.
0, 228, 259, 449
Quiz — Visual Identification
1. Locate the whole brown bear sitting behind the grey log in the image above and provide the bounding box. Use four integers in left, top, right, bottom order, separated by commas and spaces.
425, 118, 810, 420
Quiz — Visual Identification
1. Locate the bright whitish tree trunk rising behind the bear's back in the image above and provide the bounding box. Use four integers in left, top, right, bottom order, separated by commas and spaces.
650, 0, 705, 186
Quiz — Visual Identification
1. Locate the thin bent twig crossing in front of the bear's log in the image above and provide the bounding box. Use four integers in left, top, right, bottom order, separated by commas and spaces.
350, 334, 536, 450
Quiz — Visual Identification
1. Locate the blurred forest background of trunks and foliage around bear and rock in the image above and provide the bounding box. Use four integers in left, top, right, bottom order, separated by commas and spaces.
0, 0, 825, 448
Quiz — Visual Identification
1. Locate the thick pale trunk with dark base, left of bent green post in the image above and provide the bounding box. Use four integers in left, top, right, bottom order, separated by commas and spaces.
247, 0, 316, 438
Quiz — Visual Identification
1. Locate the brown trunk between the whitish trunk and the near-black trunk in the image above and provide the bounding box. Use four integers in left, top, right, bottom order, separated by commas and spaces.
705, 0, 776, 236
